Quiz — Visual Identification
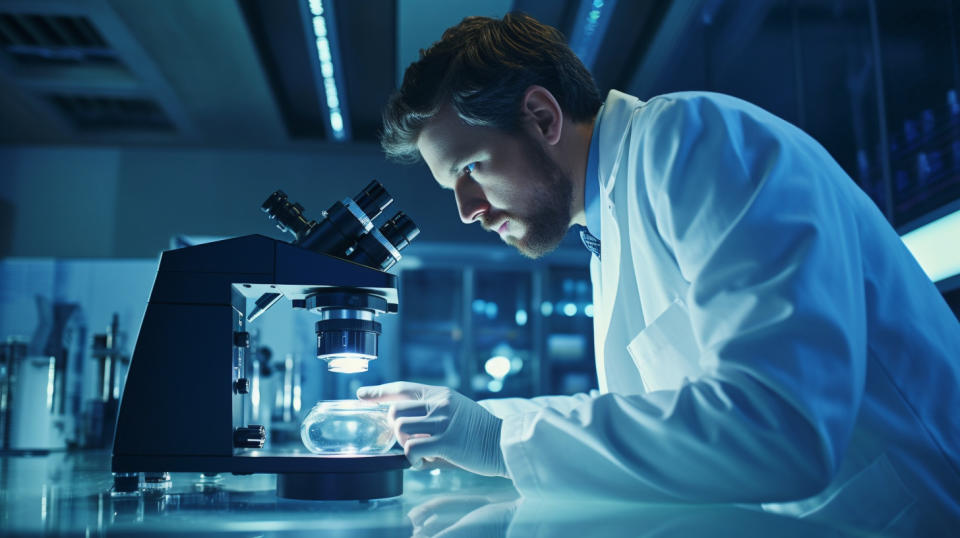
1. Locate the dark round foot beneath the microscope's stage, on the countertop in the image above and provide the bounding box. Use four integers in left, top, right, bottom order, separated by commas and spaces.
277, 469, 403, 501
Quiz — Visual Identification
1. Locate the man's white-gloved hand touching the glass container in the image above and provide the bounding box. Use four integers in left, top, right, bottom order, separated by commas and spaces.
357, 381, 507, 477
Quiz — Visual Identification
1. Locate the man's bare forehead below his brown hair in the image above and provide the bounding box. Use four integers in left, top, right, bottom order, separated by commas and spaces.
417, 105, 491, 184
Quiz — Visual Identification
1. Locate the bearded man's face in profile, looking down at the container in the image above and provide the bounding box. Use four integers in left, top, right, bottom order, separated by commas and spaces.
417, 106, 573, 258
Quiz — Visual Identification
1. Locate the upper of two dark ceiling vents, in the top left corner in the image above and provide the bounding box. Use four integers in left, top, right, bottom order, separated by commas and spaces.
0, 13, 120, 66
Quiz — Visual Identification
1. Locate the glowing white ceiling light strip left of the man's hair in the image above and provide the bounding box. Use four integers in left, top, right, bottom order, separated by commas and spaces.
308, 0, 349, 140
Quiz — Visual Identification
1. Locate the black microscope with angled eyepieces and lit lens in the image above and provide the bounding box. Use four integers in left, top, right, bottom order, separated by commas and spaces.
112, 181, 420, 500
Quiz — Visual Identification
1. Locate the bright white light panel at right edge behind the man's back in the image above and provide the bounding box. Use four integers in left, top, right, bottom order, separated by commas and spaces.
901, 206, 960, 282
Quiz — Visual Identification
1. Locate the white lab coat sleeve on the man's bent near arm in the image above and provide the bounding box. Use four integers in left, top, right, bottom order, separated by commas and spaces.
501, 94, 866, 502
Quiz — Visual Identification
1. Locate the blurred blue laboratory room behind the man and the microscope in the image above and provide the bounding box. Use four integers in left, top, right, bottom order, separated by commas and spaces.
0, 0, 960, 450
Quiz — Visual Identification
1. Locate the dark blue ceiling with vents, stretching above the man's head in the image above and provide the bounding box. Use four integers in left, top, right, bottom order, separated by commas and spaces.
0, 0, 948, 181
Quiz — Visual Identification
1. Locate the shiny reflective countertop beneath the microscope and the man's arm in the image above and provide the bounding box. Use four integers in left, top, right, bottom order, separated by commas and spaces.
0, 452, 862, 537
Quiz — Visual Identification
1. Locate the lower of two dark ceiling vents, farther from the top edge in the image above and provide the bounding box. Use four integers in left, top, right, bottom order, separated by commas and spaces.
47, 94, 175, 132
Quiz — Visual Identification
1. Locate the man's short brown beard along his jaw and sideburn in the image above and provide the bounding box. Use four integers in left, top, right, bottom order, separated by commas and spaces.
506, 135, 573, 259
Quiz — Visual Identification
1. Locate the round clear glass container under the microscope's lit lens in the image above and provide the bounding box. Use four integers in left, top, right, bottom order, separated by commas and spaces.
300, 400, 396, 454
